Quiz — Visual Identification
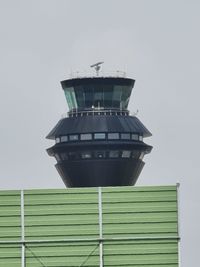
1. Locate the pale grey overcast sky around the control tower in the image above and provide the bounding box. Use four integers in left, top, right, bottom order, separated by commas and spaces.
0, 0, 200, 267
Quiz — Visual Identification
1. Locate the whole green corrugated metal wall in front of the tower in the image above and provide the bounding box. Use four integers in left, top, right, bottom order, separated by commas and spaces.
0, 186, 179, 267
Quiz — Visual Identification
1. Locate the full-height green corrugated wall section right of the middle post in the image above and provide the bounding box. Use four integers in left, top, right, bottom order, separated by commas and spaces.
102, 186, 178, 267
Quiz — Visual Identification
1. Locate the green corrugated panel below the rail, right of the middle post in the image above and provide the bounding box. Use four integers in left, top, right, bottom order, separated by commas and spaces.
104, 241, 178, 267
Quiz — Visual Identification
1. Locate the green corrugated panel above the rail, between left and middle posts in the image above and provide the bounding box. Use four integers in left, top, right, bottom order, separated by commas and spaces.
24, 189, 98, 240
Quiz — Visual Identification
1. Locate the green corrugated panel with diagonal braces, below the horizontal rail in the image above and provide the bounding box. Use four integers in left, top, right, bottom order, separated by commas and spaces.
26, 242, 99, 267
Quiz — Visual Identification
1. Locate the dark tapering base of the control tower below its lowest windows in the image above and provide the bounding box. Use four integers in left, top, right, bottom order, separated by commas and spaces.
56, 159, 144, 187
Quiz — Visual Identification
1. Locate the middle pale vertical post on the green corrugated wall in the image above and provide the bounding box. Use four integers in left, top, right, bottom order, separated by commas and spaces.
98, 187, 103, 267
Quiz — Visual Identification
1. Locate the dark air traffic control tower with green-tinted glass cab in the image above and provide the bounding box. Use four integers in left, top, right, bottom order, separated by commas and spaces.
47, 62, 152, 187
